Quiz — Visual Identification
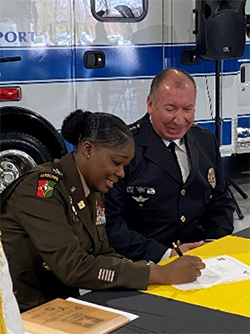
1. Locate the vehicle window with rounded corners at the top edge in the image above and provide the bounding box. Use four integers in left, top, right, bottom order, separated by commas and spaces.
91, 0, 148, 22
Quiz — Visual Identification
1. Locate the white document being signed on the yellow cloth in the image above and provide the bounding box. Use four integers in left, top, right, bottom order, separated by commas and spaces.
173, 255, 250, 290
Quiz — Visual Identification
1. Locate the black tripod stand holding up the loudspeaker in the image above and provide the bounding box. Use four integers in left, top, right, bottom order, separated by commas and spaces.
215, 60, 247, 219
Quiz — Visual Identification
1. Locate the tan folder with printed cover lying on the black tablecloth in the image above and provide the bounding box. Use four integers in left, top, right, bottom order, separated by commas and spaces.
21, 298, 131, 334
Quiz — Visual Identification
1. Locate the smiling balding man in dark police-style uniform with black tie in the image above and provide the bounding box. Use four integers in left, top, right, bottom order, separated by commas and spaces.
105, 69, 234, 262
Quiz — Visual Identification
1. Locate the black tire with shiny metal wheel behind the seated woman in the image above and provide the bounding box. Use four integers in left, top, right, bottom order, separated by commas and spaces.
0, 131, 53, 192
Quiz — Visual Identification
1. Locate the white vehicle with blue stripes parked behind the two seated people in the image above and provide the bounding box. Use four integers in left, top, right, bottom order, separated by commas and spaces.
0, 0, 250, 191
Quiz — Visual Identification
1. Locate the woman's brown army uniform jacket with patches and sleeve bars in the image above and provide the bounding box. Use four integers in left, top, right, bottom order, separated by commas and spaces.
1, 153, 149, 311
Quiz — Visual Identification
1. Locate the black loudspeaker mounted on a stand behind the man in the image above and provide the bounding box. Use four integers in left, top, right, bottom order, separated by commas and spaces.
194, 0, 246, 60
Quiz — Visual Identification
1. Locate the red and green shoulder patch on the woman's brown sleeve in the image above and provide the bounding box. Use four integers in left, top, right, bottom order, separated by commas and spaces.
36, 173, 59, 197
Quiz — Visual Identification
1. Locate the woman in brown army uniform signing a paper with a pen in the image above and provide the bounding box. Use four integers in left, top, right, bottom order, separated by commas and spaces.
1, 110, 204, 311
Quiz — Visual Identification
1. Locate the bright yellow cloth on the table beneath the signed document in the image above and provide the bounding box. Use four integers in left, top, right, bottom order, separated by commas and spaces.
143, 236, 250, 317
